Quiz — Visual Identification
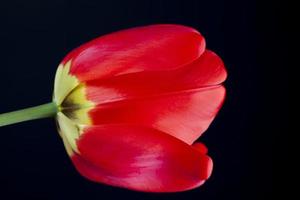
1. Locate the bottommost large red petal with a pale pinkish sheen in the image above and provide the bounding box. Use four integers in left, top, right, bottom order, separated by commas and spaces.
72, 125, 212, 192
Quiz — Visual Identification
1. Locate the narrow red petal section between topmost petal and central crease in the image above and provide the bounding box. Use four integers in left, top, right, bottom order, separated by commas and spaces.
85, 51, 227, 104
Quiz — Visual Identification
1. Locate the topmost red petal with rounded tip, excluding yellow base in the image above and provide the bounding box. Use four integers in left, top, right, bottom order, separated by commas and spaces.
63, 25, 205, 81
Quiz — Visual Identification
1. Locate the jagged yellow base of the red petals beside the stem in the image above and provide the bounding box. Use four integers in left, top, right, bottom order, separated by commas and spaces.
53, 60, 94, 156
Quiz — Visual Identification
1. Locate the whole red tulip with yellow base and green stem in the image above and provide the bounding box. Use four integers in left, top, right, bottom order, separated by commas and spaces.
0, 25, 227, 192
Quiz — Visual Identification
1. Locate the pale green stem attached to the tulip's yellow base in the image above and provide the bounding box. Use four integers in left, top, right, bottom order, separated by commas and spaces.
0, 102, 58, 127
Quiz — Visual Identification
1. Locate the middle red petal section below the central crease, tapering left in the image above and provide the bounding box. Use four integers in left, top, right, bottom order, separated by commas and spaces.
84, 86, 225, 144
